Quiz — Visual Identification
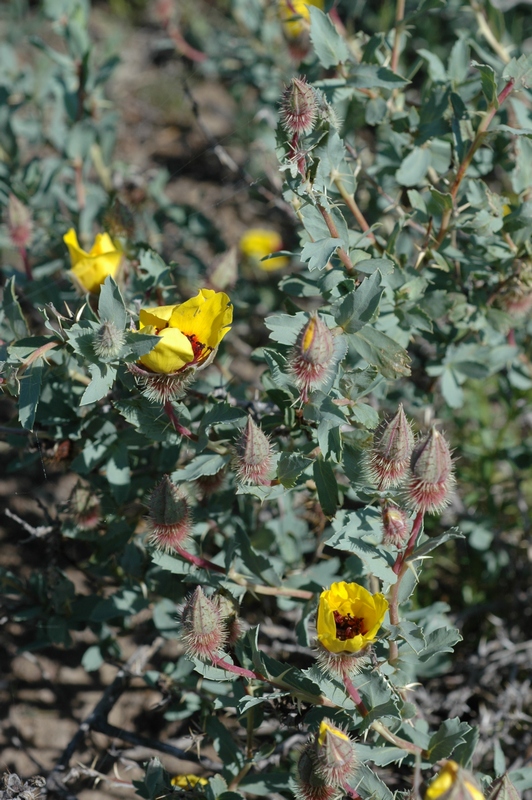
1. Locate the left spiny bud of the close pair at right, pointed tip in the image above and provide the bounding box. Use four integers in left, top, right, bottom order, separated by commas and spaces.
368, 404, 414, 490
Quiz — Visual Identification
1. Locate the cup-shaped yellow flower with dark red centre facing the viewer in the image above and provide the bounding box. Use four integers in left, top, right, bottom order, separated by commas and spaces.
317, 581, 388, 653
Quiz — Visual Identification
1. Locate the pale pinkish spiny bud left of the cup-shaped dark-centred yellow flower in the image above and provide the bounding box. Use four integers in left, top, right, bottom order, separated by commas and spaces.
181, 586, 227, 661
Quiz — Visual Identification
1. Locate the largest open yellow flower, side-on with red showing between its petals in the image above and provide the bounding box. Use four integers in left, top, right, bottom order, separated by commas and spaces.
140, 289, 233, 375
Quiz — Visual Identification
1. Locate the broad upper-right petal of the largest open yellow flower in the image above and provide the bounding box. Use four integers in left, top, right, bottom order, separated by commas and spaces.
169, 289, 233, 350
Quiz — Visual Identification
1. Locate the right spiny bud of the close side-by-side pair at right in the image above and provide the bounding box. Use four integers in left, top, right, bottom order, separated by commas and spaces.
407, 427, 455, 514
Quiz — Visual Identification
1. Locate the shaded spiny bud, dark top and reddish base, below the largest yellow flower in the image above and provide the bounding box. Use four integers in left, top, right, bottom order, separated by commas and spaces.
148, 475, 191, 550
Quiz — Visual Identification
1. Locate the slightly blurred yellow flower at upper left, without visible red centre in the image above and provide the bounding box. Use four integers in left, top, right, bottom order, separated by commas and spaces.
63, 228, 122, 293
